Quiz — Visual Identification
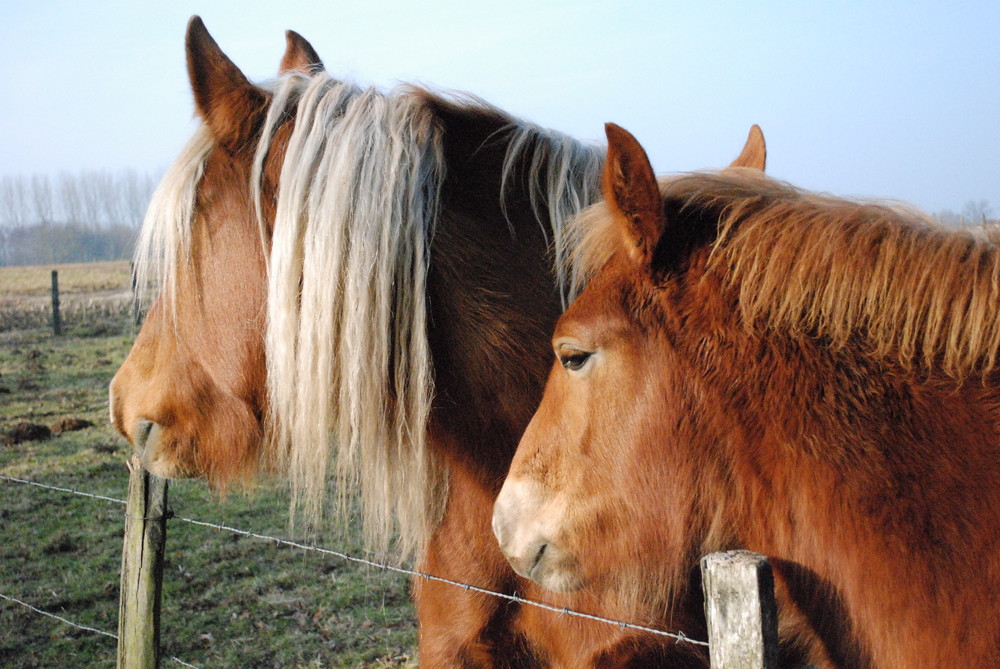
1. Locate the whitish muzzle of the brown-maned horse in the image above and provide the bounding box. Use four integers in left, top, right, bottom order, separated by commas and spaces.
493, 478, 585, 592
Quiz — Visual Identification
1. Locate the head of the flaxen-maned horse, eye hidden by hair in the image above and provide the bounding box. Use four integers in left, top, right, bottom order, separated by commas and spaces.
110, 17, 322, 487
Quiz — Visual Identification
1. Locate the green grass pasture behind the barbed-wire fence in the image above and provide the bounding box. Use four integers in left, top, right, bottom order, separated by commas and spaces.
0, 263, 416, 668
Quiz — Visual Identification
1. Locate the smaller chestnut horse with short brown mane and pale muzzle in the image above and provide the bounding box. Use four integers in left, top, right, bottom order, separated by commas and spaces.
493, 124, 1000, 669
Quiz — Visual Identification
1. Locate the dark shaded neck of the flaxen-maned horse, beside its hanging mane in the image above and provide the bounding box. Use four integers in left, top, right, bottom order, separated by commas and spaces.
428, 107, 561, 480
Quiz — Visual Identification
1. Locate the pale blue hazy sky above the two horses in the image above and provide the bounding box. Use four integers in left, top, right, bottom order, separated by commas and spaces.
0, 0, 1000, 212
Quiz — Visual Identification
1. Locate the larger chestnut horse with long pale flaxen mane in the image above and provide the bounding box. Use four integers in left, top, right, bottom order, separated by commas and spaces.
110, 17, 766, 667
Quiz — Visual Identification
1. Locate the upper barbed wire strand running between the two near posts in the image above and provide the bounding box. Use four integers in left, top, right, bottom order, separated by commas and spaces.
0, 474, 709, 647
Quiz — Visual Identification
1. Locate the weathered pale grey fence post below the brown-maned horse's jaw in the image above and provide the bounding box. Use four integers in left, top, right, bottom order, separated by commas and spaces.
701, 551, 778, 669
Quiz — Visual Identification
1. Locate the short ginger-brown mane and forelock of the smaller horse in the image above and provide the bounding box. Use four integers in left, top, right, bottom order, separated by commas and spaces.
572, 169, 1000, 379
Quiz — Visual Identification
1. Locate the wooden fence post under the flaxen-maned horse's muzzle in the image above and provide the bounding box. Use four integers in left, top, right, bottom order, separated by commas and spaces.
117, 458, 167, 669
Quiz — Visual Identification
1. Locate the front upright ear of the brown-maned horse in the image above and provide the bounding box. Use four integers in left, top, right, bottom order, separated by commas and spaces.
603, 123, 664, 264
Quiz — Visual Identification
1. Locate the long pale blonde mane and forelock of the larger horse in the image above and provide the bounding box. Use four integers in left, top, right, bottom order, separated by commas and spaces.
137, 73, 603, 556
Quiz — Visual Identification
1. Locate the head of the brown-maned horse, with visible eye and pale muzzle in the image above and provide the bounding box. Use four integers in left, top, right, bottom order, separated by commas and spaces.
493, 124, 766, 592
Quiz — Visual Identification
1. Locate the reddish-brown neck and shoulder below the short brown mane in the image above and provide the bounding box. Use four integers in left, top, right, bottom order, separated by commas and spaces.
668, 253, 1000, 667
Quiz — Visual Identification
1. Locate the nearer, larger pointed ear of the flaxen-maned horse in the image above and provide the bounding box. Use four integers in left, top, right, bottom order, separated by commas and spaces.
186, 16, 267, 148
